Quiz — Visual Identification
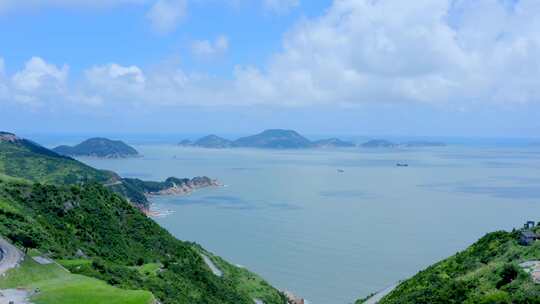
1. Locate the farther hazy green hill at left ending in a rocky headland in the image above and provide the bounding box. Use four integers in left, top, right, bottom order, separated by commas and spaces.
0, 132, 217, 209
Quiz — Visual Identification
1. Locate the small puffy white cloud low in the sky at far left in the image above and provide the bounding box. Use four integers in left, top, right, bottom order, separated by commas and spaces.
12, 57, 69, 92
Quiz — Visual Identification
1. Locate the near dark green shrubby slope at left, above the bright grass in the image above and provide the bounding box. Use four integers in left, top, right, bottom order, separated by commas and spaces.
0, 180, 285, 304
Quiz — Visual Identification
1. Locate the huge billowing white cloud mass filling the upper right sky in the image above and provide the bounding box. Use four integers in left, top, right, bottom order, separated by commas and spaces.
229, 0, 540, 104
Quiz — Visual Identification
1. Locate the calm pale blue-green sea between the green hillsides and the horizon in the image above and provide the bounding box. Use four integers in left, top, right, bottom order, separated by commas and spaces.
83, 145, 540, 304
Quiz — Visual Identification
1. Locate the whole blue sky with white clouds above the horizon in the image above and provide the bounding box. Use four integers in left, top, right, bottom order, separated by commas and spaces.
0, 0, 540, 138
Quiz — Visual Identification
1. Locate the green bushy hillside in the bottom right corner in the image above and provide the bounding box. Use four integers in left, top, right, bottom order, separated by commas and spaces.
357, 231, 540, 304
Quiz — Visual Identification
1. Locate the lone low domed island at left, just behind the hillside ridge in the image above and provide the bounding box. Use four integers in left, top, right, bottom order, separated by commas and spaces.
52, 137, 139, 158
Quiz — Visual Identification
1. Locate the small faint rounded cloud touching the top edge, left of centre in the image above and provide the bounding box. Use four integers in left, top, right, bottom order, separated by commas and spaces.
146, 0, 187, 34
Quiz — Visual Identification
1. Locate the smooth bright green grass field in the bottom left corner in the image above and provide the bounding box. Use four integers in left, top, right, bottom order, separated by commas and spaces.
0, 257, 154, 304
